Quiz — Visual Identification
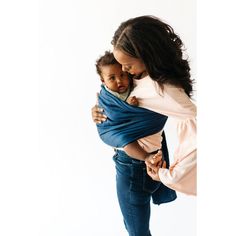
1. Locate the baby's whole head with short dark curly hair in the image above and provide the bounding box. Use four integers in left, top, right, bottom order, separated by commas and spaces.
96, 51, 130, 93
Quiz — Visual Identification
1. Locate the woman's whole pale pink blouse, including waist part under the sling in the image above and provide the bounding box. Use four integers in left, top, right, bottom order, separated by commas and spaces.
130, 76, 197, 195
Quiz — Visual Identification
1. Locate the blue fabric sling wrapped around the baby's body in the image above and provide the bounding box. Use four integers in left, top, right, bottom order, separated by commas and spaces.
97, 85, 167, 147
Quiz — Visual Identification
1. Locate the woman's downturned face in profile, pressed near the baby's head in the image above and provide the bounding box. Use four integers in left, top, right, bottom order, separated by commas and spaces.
113, 49, 146, 78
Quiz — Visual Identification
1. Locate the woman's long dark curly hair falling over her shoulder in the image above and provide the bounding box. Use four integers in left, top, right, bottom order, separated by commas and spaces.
111, 16, 193, 97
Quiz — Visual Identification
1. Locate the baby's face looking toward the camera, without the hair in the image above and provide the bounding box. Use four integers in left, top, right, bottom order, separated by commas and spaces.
101, 64, 129, 93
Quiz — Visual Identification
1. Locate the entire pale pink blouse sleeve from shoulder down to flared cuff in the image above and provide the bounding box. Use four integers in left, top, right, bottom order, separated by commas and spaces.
156, 87, 197, 195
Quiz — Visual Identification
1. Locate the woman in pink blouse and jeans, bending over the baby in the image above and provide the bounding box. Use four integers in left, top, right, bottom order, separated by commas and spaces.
92, 16, 196, 236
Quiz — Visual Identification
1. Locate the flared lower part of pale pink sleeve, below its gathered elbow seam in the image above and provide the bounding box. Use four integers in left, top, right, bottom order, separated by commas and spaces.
159, 118, 197, 195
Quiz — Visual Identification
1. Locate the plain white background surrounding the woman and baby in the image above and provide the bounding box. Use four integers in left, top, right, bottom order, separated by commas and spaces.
0, 0, 235, 236
